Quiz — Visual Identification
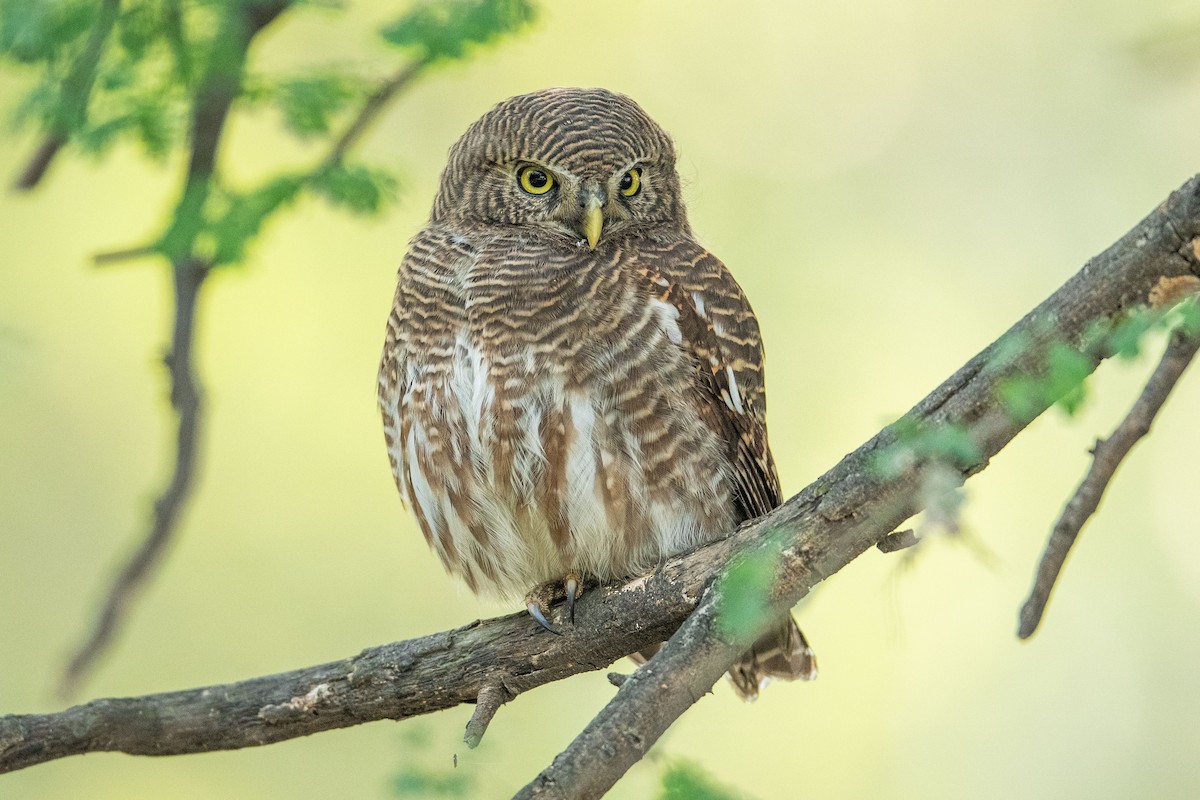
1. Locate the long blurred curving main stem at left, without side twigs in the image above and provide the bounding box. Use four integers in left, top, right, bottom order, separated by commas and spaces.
60, 0, 289, 696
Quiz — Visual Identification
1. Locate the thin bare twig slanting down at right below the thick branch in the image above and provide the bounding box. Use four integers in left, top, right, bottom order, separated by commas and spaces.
1016, 321, 1200, 639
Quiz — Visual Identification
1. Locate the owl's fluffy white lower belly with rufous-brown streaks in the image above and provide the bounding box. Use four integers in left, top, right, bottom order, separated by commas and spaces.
384, 326, 728, 596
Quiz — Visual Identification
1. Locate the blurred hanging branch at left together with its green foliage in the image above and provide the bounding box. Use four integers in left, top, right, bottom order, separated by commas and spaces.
0, 0, 535, 694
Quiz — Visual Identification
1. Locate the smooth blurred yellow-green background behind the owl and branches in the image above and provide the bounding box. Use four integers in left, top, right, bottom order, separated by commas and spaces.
0, 0, 1200, 800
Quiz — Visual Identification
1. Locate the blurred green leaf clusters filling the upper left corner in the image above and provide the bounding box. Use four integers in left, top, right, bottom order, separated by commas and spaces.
0, 0, 535, 266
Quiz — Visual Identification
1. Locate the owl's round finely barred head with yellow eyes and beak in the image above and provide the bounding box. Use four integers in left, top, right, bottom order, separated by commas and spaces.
433, 89, 688, 249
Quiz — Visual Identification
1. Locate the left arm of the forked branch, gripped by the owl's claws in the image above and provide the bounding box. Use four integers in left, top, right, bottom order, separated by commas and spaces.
0, 540, 731, 772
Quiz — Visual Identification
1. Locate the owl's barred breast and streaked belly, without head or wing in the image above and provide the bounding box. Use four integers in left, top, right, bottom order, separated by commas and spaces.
394, 241, 733, 594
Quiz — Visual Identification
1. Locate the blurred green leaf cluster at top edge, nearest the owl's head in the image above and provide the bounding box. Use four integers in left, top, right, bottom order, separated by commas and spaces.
382, 0, 535, 61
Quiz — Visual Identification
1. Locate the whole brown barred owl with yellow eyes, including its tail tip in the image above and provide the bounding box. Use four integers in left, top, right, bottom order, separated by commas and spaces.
379, 89, 816, 697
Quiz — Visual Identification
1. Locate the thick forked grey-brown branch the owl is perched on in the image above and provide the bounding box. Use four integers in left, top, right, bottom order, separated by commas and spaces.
0, 178, 1200, 798
